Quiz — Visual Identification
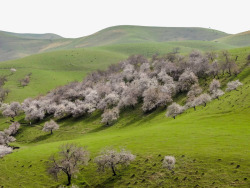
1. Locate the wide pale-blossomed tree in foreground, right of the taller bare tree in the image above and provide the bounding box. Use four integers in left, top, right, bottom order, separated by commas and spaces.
95, 149, 136, 176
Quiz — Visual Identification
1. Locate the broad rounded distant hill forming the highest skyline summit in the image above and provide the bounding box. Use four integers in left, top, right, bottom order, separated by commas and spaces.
64, 25, 228, 48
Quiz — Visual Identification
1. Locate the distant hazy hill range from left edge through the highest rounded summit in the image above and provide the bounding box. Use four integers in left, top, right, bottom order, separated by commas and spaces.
0, 26, 229, 61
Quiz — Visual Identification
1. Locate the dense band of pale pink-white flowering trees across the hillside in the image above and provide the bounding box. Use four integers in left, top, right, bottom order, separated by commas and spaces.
2, 51, 244, 125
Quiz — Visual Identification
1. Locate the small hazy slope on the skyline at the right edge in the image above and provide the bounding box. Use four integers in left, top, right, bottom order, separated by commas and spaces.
216, 31, 250, 46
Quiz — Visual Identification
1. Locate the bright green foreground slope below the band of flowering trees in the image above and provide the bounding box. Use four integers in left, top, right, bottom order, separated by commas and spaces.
0, 48, 250, 187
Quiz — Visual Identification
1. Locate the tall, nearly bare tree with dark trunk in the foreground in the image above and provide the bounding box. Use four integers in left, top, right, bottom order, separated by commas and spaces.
48, 144, 89, 185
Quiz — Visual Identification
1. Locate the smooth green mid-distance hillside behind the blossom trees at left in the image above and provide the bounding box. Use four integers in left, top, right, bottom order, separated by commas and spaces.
0, 49, 126, 101
